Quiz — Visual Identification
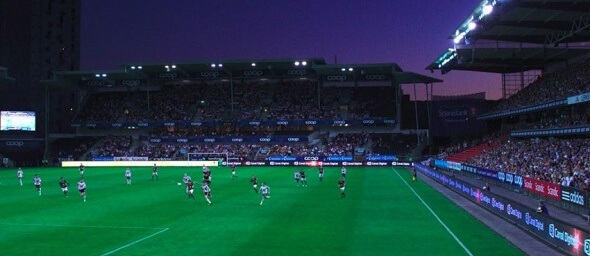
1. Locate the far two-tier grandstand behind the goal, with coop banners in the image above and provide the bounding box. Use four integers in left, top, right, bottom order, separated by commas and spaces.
35, 58, 441, 164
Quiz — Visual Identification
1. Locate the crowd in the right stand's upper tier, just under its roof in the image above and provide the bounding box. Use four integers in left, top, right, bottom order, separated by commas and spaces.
490, 59, 590, 112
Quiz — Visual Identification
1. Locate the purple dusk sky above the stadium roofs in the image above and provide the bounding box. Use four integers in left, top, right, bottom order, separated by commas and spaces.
81, 0, 501, 99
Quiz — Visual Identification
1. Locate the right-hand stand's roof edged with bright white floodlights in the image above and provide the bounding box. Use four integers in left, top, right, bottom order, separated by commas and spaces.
426, 0, 590, 73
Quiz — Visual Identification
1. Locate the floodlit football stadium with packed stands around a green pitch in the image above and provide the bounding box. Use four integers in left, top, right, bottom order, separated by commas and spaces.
0, 0, 590, 256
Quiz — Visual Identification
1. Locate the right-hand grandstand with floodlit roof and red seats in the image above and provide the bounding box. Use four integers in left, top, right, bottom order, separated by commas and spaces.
426, 0, 590, 255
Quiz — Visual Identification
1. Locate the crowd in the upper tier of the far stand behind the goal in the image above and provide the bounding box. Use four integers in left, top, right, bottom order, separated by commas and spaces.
74, 80, 395, 123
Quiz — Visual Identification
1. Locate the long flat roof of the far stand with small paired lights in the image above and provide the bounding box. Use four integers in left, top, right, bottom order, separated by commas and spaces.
44, 58, 442, 89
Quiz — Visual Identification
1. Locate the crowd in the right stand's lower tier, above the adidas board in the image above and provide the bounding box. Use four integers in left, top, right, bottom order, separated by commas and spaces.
466, 138, 590, 189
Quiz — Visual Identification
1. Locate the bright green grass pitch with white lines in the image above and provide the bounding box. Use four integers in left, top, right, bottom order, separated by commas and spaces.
0, 167, 523, 256
